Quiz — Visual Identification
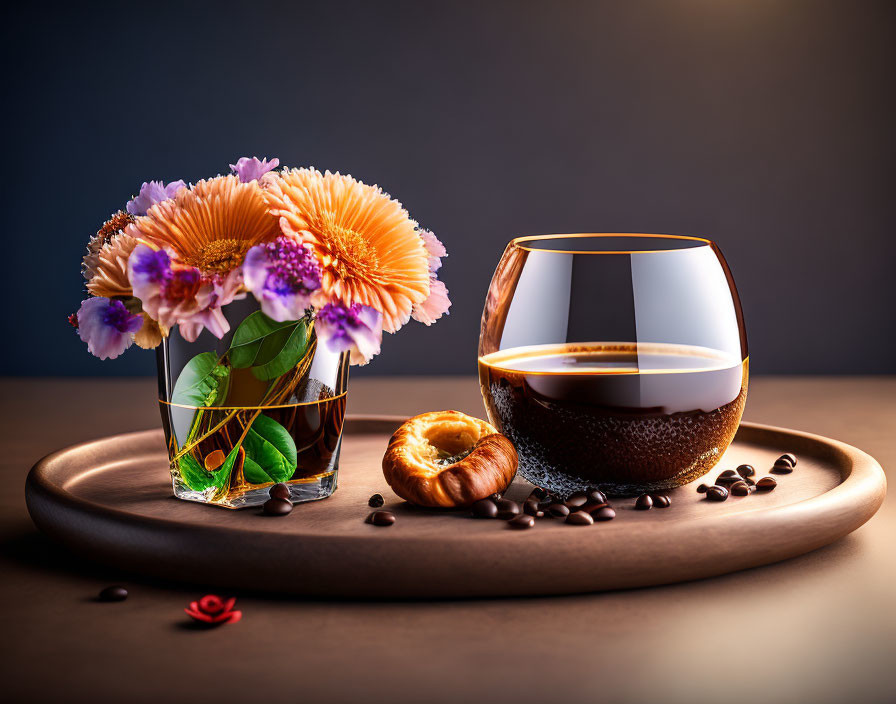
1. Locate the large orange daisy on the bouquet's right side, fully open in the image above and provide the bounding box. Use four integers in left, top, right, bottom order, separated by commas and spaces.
264, 169, 430, 332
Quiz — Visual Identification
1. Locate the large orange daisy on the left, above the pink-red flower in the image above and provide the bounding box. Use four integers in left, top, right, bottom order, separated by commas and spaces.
127, 176, 280, 274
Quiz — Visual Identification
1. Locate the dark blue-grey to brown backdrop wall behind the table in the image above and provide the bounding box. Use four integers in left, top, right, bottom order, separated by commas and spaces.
0, 0, 896, 375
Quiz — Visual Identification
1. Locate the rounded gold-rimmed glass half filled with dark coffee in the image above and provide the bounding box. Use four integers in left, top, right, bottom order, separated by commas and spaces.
479, 234, 748, 495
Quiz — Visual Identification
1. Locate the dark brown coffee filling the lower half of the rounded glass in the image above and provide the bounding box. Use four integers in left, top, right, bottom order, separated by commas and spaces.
479, 343, 748, 494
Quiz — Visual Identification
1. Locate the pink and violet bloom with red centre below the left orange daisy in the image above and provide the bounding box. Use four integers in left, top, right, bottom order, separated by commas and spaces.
128, 244, 242, 342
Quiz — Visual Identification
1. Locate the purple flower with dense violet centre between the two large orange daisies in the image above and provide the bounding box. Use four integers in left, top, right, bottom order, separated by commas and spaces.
243, 237, 320, 323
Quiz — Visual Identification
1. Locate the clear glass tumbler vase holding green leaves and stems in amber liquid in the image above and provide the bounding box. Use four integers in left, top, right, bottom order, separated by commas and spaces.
157, 300, 349, 508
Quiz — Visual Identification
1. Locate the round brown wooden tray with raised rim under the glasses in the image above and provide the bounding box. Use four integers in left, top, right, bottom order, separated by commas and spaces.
26, 416, 886, 598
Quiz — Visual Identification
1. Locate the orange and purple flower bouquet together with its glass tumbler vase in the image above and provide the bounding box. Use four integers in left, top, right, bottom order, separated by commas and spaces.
70, 157, 450, 508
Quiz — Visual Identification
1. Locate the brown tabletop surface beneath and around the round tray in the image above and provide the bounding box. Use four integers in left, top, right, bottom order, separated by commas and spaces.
0, 377, 896, 704
